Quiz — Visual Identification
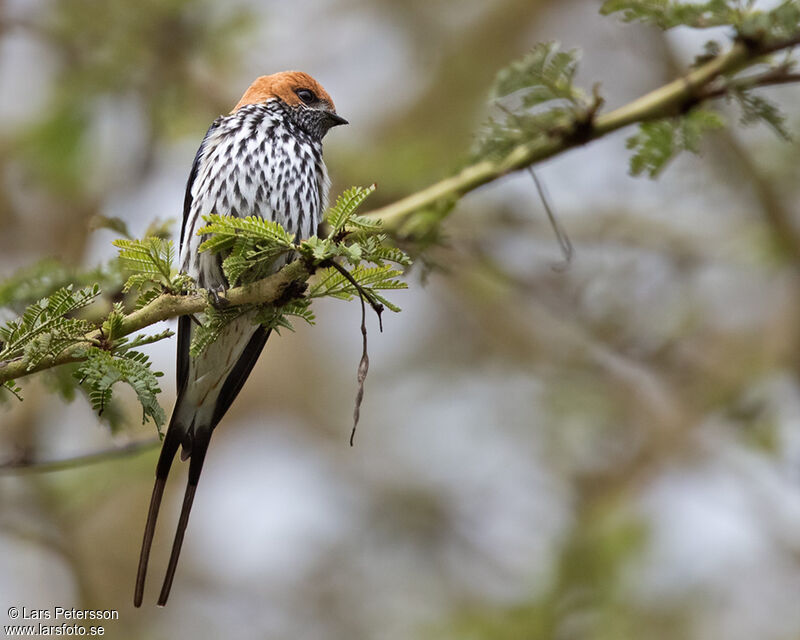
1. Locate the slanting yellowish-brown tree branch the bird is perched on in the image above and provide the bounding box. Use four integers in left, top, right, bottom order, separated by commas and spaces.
0, 35, 800, 383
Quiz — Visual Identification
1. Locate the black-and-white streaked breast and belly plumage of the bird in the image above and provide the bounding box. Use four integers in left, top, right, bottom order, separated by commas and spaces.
180, 98, 330, 288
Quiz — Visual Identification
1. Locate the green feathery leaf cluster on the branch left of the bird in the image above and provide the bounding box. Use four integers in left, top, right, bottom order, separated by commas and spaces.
0, 235, 181, 428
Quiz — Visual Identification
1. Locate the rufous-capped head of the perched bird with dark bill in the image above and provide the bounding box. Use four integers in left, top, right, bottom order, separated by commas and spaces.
231, 71, 348, 137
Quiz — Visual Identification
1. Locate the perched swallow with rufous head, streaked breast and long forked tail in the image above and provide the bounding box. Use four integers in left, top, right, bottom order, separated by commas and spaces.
134, 71, 347, 607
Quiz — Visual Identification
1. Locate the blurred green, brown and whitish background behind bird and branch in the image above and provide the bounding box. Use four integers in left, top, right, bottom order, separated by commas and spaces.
0, 0, 800, 640
